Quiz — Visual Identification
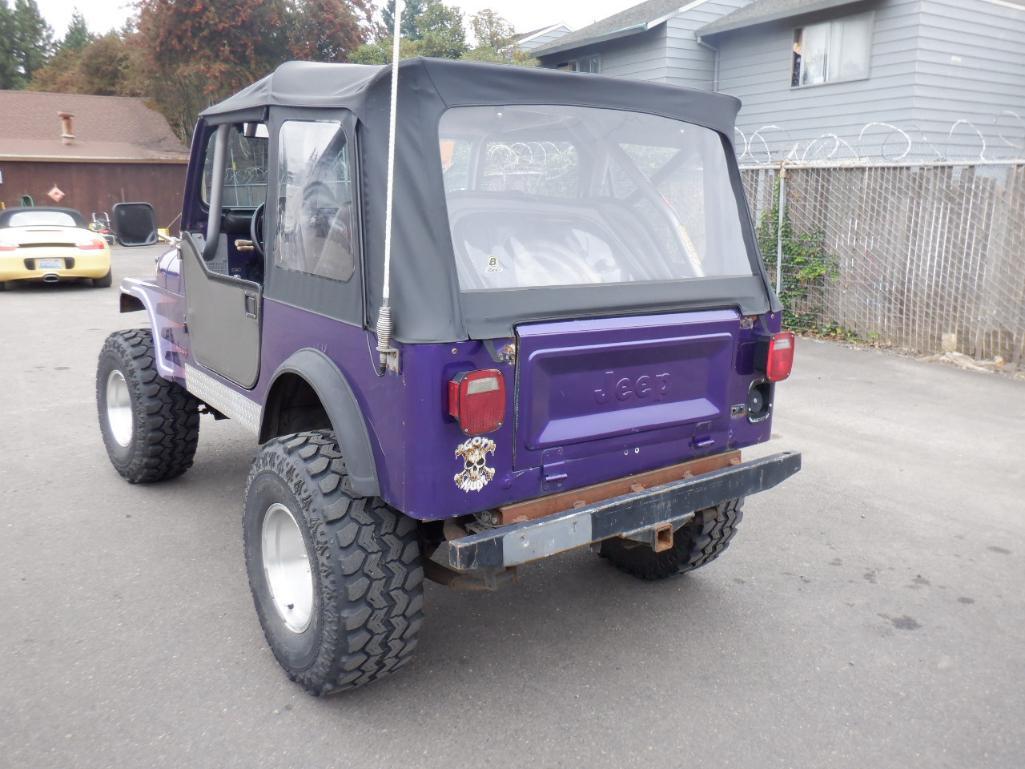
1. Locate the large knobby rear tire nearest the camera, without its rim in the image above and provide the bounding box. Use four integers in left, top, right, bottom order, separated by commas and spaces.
243, 430, 423, 695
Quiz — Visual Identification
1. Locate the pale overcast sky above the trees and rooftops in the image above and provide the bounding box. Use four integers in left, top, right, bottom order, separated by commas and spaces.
36, 0, 623, 39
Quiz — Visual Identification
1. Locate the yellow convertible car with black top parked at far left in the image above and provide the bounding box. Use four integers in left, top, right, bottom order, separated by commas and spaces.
0, 208, 111, 290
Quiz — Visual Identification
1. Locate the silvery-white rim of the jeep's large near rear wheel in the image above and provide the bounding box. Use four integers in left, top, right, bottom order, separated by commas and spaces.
261, 502, 314, 633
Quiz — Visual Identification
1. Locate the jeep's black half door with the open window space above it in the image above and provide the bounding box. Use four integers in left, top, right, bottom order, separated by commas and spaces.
180, 123, 268, 389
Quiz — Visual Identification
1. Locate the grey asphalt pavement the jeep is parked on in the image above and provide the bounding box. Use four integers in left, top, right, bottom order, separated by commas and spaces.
0, 249, 1025, 769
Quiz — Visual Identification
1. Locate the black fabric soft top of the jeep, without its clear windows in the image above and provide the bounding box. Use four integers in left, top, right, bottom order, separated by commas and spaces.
201, 58, 775, 342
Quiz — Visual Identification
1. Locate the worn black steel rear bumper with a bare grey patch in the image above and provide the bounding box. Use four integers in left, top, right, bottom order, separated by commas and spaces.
432, 451, 801, 572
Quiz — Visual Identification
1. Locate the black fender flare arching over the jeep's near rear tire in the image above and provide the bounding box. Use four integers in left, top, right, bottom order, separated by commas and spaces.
259, 348, 380, 496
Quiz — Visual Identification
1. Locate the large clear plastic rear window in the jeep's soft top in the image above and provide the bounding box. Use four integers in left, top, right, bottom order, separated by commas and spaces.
440, 106, 752, 291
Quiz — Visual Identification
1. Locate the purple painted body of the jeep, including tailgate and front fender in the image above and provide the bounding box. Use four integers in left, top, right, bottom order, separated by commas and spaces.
130, 252, 780, 520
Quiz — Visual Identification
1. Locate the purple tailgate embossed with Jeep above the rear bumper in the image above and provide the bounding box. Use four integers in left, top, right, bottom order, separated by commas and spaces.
515, 310, 740, 469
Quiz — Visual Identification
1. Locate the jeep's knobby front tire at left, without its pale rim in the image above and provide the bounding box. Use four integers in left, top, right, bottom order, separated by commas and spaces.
96, 328, 199, 483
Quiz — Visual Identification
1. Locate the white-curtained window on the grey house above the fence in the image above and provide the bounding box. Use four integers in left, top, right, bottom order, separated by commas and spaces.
790, 13, 872, 88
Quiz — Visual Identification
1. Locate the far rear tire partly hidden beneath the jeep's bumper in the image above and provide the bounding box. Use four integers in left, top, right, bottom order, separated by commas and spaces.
601, 497, 744, 579
